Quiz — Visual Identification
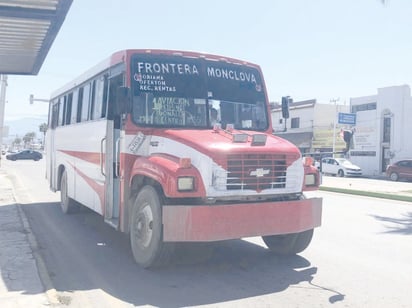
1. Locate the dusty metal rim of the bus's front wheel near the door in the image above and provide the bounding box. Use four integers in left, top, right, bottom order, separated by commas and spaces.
134, 204, 153, 248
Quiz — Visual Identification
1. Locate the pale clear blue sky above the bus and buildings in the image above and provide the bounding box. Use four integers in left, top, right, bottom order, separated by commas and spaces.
5, 0, 412, 121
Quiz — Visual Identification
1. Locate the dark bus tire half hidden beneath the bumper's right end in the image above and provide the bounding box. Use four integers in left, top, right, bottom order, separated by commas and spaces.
262, 229, 313, 256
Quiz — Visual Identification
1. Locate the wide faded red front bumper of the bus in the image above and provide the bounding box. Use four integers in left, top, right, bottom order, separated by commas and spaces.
163, 198, 322, 242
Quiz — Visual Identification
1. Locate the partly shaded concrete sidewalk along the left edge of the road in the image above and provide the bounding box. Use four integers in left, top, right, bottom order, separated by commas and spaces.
0, 168, 54, 308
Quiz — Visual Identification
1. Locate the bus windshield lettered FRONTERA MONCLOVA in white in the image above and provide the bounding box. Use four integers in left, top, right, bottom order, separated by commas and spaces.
132, 55, 268, 131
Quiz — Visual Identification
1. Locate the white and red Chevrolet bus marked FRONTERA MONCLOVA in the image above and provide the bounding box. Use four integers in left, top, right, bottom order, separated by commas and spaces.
46, 50, 322, 267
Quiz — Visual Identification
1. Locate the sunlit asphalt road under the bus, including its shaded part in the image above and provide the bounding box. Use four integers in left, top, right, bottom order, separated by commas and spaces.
6, 160, 412, 308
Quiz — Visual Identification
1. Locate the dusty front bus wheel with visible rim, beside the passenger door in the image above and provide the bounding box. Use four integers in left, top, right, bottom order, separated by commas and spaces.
130, 185, 173, 268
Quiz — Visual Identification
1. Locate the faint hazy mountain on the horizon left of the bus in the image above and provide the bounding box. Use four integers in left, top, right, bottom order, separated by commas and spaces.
3, 115, 47, 143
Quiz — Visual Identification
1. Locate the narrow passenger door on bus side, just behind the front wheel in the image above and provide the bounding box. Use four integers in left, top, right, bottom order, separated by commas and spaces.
101, 74, 123, 229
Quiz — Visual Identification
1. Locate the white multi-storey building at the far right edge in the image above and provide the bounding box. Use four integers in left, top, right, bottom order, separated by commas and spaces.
349, 85, 412, 176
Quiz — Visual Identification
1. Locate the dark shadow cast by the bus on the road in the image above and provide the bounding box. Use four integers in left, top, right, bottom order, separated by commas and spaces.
24, 203, 344, 307
